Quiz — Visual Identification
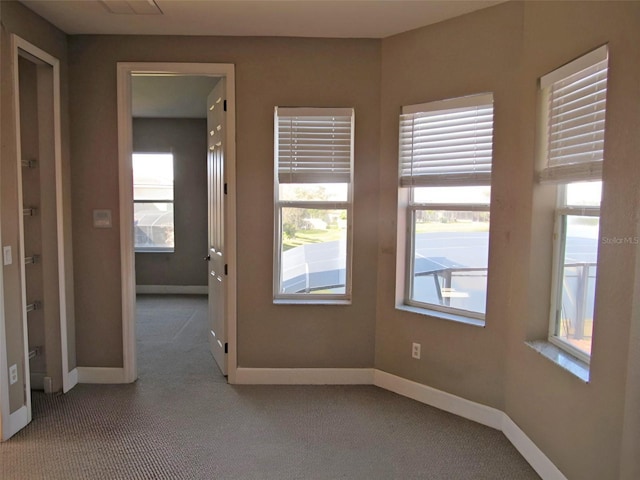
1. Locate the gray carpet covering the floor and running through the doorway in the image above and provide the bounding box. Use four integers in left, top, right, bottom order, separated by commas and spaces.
0, 296, 539, 480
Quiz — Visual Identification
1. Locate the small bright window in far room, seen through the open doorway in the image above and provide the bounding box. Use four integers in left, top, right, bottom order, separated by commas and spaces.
133, 153, 175, 252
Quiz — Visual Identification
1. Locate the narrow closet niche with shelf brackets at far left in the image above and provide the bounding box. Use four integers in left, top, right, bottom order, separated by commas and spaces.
18, 53, 62, 393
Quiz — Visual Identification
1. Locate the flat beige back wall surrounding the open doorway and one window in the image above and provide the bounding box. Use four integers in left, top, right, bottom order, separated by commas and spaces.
70, 36, 380, 367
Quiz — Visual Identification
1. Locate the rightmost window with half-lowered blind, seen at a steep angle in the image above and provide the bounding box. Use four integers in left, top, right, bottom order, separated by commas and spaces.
540, 46, 608, 363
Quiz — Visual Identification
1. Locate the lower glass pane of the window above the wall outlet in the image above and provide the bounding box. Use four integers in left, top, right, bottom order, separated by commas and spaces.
410, 210, 489, 314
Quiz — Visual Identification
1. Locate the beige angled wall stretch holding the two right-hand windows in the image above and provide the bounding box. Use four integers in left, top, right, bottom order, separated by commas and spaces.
376, 2, 640, 480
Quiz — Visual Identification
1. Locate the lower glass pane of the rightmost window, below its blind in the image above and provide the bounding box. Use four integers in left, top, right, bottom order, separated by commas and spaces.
555, 215, 600, 355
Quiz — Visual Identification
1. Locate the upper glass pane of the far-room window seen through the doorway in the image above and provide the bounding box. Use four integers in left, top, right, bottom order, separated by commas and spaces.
133, 153, 173, 200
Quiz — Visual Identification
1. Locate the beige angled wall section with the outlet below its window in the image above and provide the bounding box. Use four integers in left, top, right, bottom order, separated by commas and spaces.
376, 0, 533, 409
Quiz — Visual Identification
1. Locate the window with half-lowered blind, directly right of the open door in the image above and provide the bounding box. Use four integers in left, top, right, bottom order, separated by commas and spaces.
274, 107, 354, 302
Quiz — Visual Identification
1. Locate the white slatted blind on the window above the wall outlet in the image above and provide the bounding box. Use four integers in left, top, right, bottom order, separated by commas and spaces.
399, 93, 493, 187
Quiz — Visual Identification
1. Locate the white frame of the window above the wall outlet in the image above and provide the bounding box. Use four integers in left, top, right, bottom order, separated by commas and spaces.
396, 93, 494, 326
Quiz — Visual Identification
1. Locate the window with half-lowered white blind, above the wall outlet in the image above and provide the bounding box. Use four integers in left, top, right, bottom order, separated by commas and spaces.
399, 94, 493, 323
